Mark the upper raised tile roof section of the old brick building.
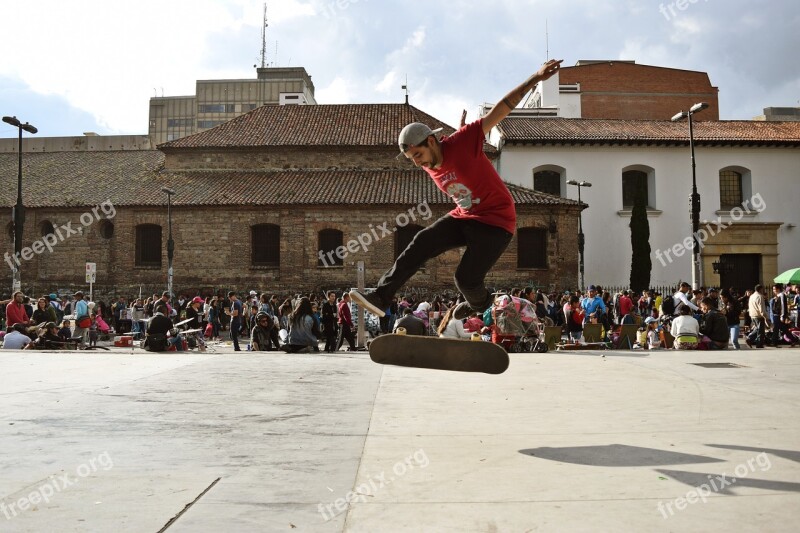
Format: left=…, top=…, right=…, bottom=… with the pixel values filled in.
left=159, top=104, right=455, bottom=151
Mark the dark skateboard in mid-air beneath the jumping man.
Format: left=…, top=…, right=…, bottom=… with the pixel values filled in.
left=369, top=334, right=508, bottom=374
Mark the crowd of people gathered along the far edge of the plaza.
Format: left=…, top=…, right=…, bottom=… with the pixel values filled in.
left=0, top=283, right=800, bottom=353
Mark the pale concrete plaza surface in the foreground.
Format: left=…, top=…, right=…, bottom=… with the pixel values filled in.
left=0, top=342, right=800, bottom=533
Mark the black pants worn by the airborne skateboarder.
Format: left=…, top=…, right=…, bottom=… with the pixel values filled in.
left=375, top=215, right=513, bottom=310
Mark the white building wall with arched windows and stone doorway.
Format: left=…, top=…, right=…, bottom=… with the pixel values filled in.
left=498, top=145, right=800, bottom=286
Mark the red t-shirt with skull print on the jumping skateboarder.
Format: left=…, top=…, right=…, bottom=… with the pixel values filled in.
left=425, top=120, right=517, bottom=234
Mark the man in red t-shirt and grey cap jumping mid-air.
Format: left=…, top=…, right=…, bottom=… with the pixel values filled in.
left=350, top=60, right=561, bottom=320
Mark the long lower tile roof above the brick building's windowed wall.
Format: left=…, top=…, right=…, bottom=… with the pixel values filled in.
left=0, top=150, right=578, bottom=208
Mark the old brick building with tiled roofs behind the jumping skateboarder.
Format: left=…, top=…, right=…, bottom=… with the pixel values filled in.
left=0, top=104, right=580, bottom=298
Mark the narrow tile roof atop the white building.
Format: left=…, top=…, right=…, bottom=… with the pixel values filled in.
left=498, top=117, right=800, bottom=146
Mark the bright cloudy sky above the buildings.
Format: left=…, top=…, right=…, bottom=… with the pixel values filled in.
left=0, top=0, right=800, bottom=137
